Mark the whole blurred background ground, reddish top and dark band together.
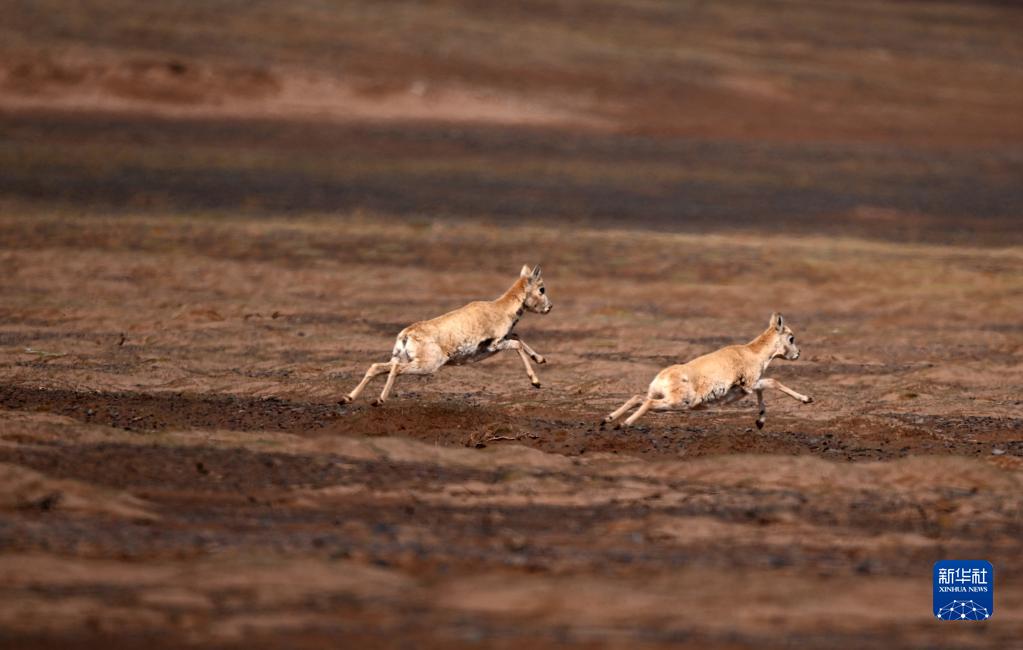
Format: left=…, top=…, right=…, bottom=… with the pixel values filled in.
left=6, top=0, right=1023, bottom=244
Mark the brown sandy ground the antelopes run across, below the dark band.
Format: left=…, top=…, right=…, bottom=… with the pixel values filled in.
left=0, top=215, right=1023, bottom=648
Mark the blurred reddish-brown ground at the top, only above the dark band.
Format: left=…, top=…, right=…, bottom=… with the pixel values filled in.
left=0, top=0, right=1023, bottom=146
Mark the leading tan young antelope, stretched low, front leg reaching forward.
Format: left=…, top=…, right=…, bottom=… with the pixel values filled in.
left=601, top=313, right=813, bottom=429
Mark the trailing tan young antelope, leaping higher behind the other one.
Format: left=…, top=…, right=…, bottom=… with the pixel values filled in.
left=340, top=266, right=551, bottom=406
